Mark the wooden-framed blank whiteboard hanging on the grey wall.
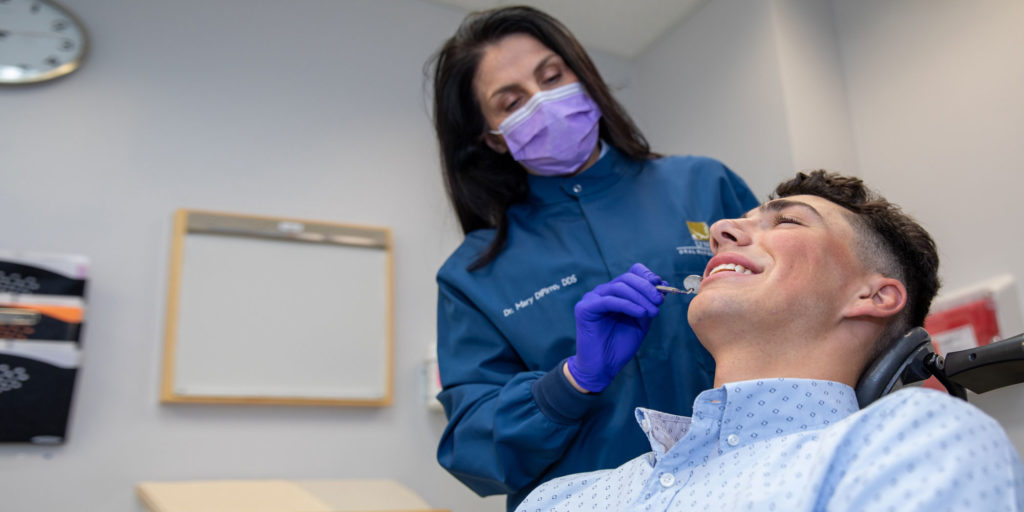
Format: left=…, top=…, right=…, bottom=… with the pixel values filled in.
left=161, top=210, right=394, bottom=406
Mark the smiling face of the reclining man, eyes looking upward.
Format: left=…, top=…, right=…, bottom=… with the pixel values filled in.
left=688, top=196, right=866, bottom=336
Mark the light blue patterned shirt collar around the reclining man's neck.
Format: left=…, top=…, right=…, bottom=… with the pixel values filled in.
left=636, top=379, right=858, bottom=459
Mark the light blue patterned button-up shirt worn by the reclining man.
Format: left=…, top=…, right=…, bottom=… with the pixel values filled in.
left=516, top=379, right=1024, bottom=512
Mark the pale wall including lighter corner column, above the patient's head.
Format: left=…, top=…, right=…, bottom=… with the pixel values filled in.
left=627, top=0, right=856, bottom=198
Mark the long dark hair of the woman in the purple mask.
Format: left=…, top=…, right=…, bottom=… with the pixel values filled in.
left=426, top=6, right=657, bottom=270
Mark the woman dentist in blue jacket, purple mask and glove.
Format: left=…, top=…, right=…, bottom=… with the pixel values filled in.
left=429, top=7, right=758, bottom=510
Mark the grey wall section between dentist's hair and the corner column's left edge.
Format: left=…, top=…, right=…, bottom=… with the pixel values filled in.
left=628, top=1, right=793, bottom=197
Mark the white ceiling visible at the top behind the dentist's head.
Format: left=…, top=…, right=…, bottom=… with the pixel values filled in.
left=428, top=0, right=708, bottom=58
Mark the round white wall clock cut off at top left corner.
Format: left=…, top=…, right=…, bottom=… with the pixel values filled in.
left=0, top=0, right=86, bottom=84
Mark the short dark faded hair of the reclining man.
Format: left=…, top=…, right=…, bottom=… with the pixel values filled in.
left=771, top=170, right=940, bottom=350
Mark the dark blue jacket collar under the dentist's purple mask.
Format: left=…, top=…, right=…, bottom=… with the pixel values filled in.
left=526, top=141, right=636, bottom=204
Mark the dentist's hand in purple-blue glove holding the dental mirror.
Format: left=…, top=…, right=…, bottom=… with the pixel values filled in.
left=567, top=263, right=665, bottom=393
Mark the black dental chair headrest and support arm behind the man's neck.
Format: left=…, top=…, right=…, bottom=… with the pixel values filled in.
left=856, top=327, right=1024, bottom=409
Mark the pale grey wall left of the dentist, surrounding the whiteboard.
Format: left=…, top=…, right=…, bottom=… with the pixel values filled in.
left=0, top=0, right=504, bottom=512
